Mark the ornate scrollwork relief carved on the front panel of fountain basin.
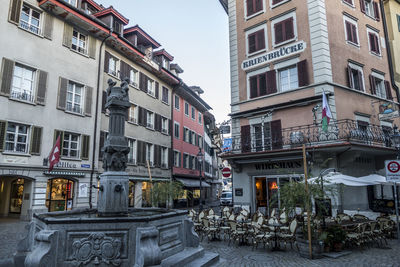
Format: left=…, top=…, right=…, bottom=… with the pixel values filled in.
left=72, top=233, right=121, bottom=266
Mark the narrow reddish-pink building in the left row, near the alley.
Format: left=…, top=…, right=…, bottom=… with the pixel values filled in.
left=172, top=83, right=211, bottom=206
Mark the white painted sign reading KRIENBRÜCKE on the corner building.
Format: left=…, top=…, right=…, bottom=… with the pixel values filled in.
left=242, top=41, right=307, bottom=70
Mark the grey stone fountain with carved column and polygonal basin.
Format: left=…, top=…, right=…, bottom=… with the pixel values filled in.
left=9, top=80, right=219, bottom=267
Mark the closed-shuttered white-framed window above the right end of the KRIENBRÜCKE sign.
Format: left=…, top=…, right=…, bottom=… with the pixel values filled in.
left=272, top=13, right=297, bottom=45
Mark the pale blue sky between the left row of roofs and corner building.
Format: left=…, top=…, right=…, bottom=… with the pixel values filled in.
left=96, top=0, right=230, bottom=123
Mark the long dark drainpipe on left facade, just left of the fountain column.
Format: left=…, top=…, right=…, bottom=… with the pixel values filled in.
left=89, top=28, right=113, bottom=209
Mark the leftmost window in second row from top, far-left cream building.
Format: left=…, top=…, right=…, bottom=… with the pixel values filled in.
left=11, top=64, right=35, bottom=102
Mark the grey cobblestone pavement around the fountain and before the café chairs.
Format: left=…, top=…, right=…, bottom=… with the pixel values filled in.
left=0, top=218, right=400, bottom=267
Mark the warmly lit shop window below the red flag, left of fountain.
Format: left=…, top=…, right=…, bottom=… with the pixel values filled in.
left=46, top=178, right=74, bottom=212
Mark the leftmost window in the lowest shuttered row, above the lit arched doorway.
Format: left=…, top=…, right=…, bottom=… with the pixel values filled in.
left=5, top=122, right=29, bottom=153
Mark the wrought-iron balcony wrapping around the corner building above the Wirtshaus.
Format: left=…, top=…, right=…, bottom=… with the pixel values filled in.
left=228, top=119, right=393, bottom=153
